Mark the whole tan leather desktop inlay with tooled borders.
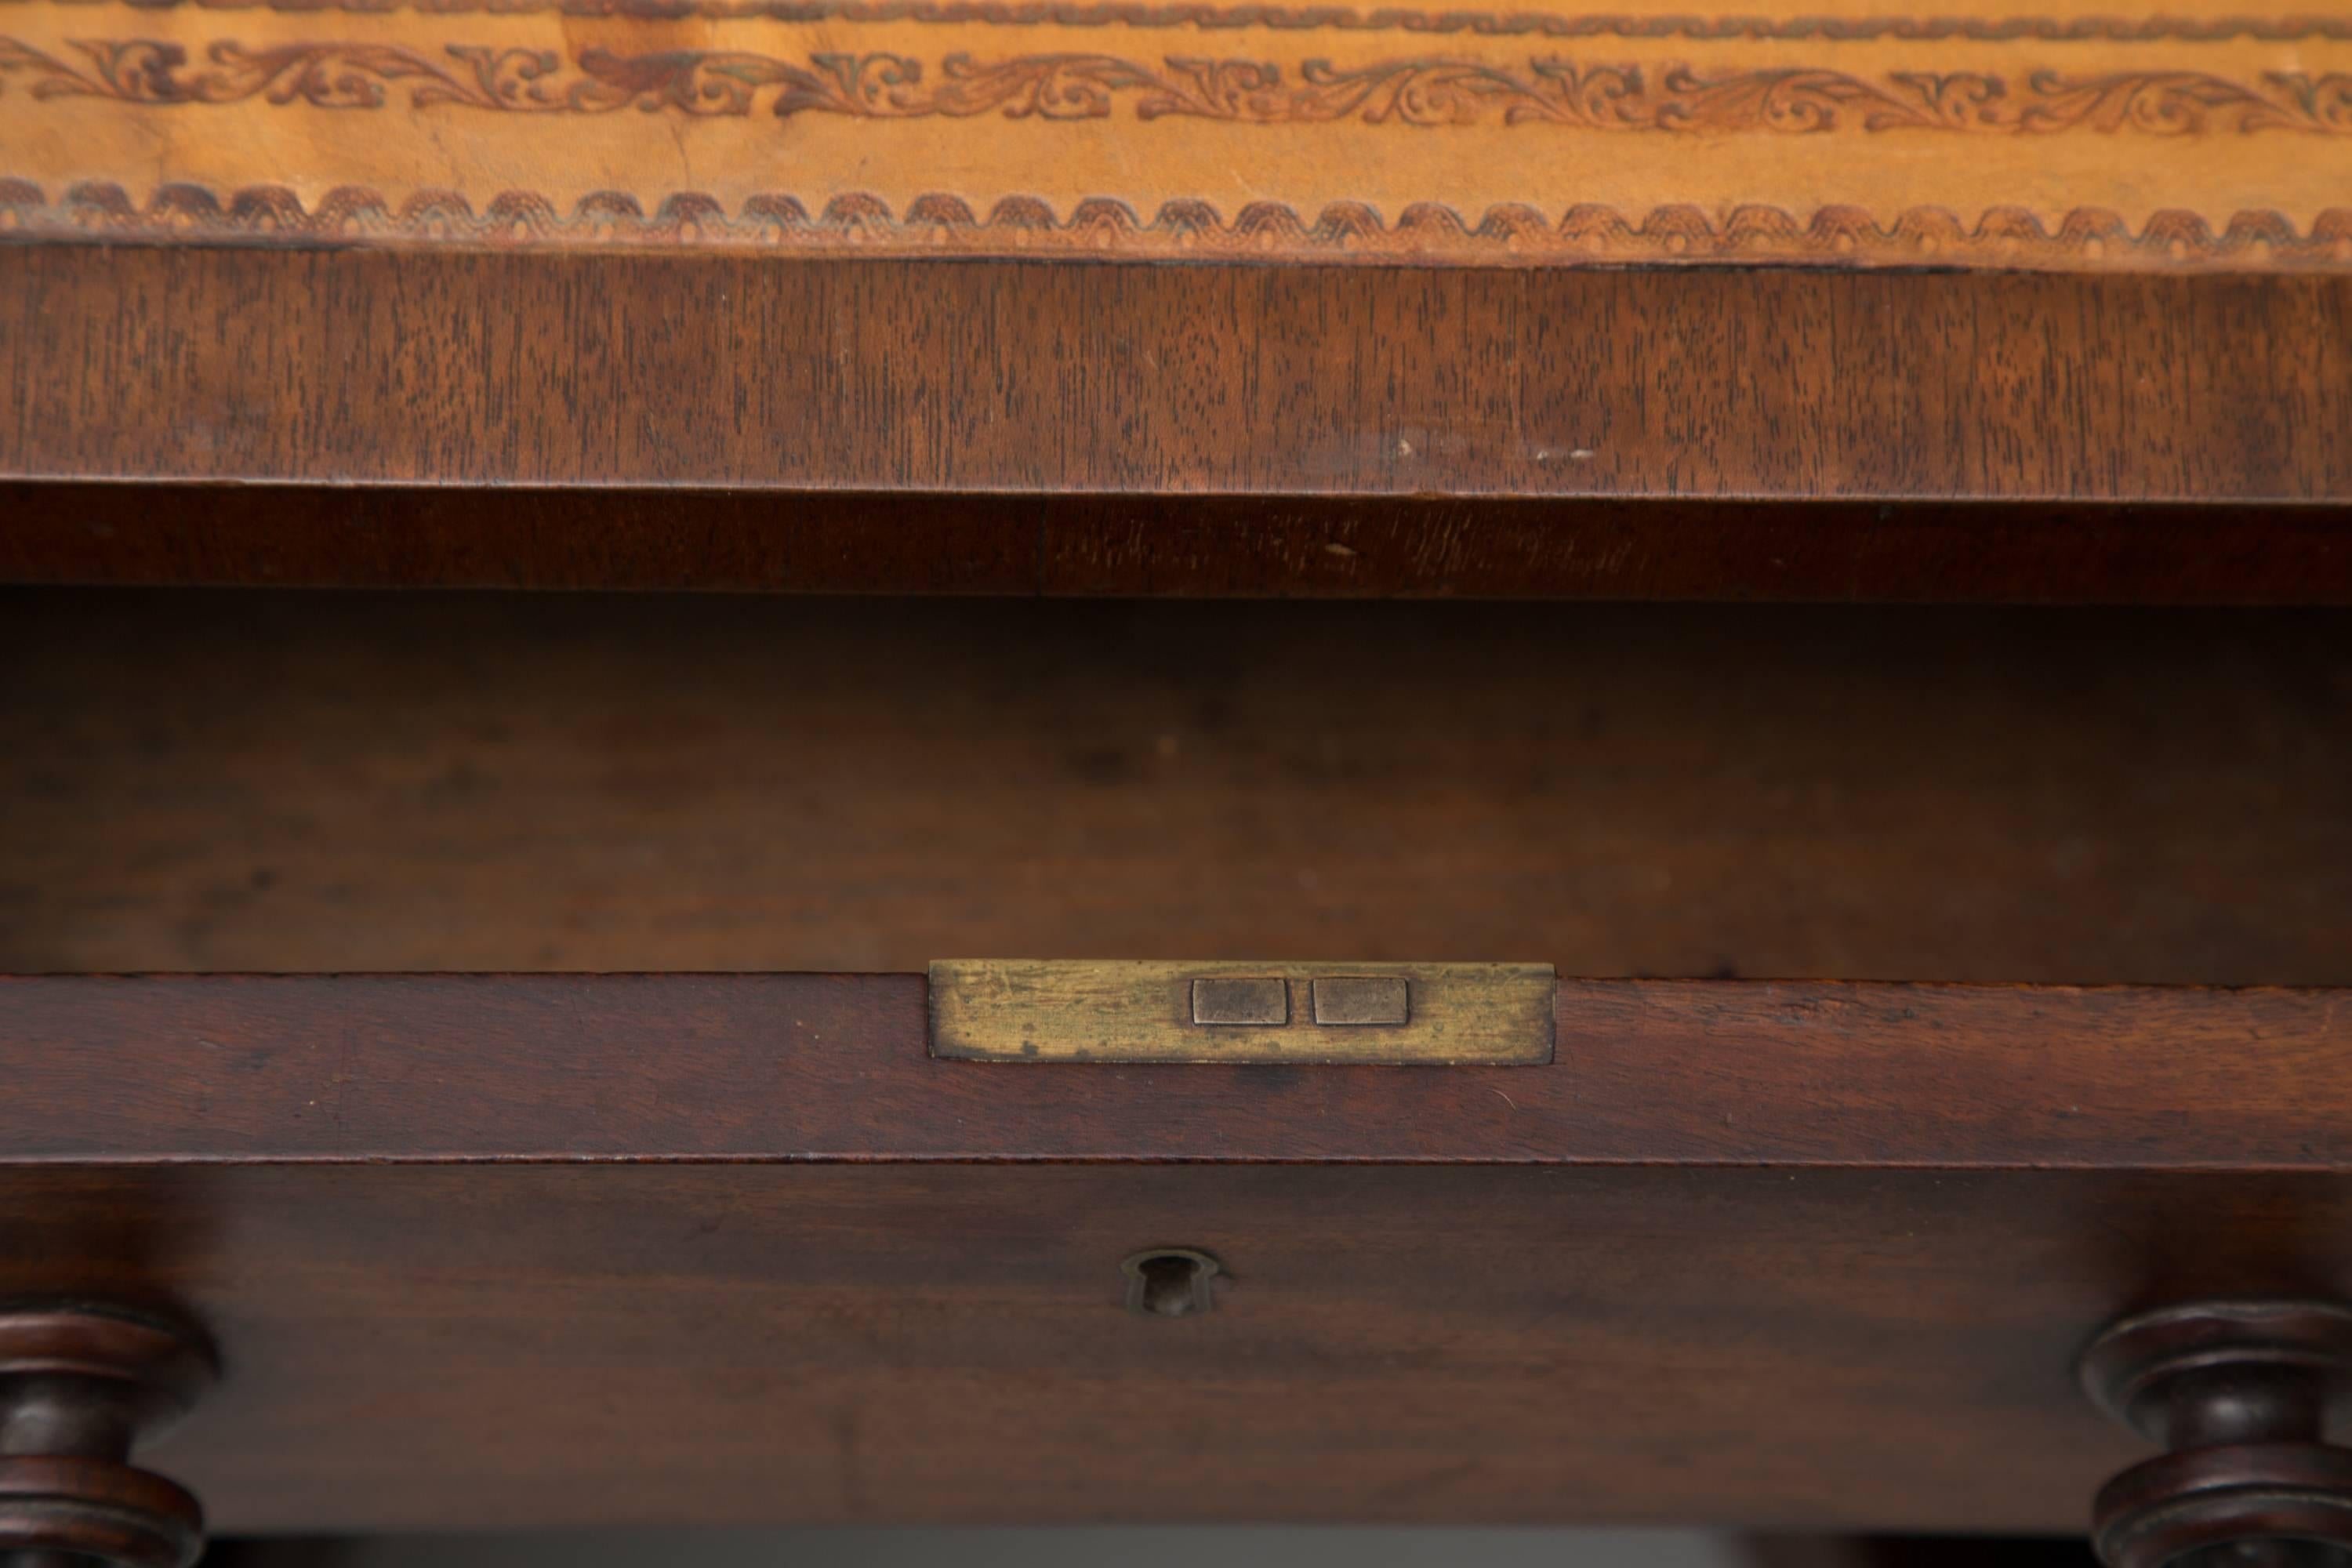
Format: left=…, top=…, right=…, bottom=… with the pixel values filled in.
left=0, top=0, right=2352, bottom=268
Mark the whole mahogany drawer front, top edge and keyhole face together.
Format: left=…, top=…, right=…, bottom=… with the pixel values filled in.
left=0, top=975, right=2352, bottom=1530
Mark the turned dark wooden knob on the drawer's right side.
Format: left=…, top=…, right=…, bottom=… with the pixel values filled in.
left=2082, top=1302, right=2352, bottom=1568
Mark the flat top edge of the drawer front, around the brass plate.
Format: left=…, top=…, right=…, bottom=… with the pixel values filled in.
left=0, top=975, right=2352, bottom=1173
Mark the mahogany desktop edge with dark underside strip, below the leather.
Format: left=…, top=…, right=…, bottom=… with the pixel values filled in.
left=0, top=255, right=2352, bottom=604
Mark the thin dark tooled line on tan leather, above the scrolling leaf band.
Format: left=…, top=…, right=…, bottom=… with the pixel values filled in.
left=0, top=0, right=2352, bottom=42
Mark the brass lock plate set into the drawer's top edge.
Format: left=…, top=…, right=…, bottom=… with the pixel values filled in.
left=931, top=959, right=1552, bottom=1067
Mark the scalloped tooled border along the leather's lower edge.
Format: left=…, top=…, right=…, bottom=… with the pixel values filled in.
left=0, top=179, right=2352, bottom=273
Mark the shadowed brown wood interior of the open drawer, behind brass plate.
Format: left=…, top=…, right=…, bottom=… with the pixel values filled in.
left=0, top=590, right=2352, bottom=985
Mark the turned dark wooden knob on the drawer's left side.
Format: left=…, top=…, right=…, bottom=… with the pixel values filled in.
left=0, top=1302, right=214, bottom=1568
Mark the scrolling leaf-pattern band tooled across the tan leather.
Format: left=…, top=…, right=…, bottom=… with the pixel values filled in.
left=0, top=38, right=2352, bottom=136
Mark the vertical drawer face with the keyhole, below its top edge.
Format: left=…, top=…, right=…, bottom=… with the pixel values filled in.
left=0, top=1166, right=2352, bottom=1533
